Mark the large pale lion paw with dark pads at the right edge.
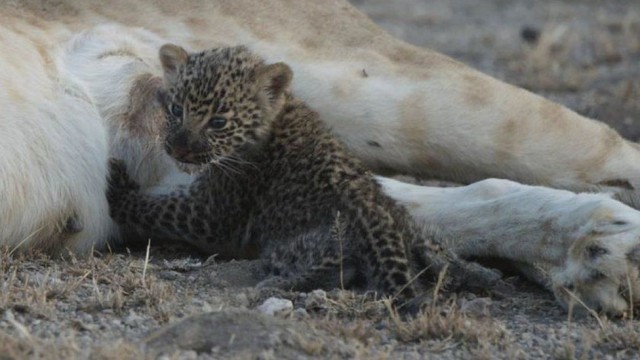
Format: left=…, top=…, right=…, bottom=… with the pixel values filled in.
left=550, top=200, right=640, bottom=315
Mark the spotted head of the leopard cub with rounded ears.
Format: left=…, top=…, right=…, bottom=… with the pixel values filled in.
left=160, top=44, right=293, bottom=164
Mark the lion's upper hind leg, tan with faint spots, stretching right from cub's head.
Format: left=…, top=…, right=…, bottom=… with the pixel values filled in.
left=293, top=58, right=640, bottom=202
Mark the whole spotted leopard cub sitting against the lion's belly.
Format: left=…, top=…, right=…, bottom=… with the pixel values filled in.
left=108, top=44, right=496, bottom=308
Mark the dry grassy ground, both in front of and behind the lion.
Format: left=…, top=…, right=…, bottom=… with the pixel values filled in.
left=0, top=0, right=640, bottom=359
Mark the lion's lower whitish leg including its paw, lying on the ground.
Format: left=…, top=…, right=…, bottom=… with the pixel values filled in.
left=378, top=177, right=640, bottom=314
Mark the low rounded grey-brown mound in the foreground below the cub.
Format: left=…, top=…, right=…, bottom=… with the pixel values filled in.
left=142, top=308, right=355, bottom=359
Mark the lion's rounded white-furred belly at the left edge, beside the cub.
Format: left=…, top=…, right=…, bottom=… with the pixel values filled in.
left=0, top=24, right=113, bottom=252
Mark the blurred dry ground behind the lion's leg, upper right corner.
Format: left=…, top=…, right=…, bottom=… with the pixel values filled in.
left=350, top=0, right=640, bottom=141
